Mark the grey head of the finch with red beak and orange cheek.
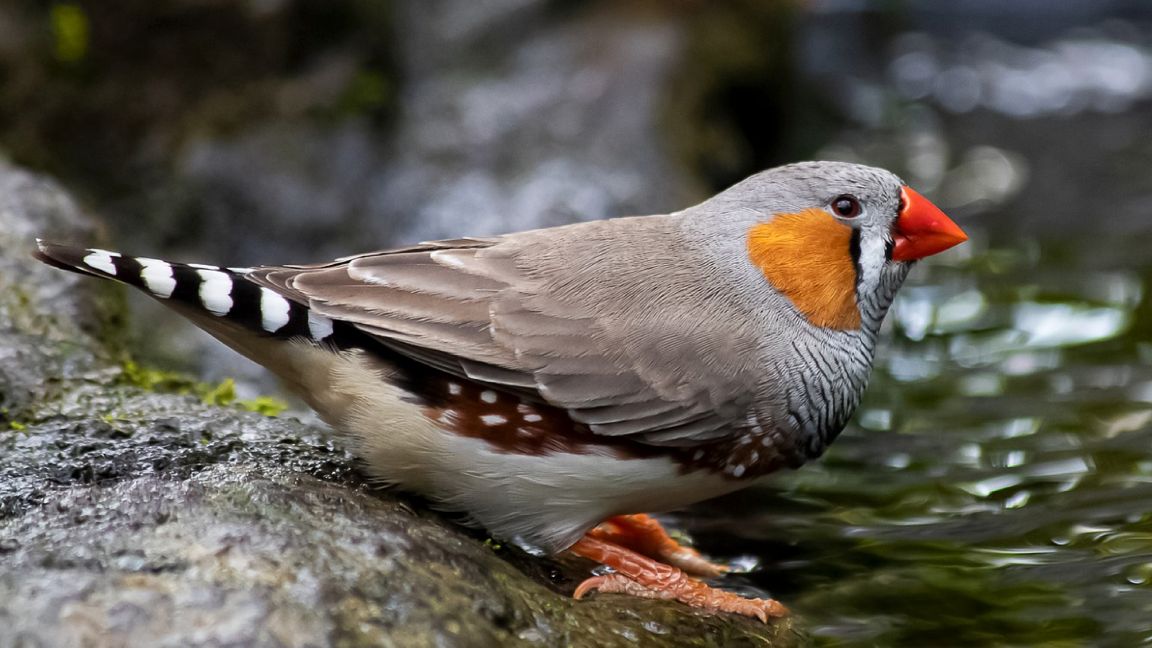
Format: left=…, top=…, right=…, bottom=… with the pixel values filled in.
left=697, top=161, right=968, bottom=331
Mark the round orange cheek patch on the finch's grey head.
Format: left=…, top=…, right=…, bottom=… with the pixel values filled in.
left=748, top=209, right=861, bottom=330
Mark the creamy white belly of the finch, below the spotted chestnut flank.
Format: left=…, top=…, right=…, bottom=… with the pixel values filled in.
left=281, top=344, right=746, bottom=551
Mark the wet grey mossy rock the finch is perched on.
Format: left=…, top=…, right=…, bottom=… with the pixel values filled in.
left=0, top=166, right=797, bottom=647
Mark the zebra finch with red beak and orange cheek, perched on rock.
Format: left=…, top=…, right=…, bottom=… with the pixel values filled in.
left=33, top=161, right=968, bottom=621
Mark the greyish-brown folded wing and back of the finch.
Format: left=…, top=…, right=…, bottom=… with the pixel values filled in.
left=249, top=217, right=757, bottom=445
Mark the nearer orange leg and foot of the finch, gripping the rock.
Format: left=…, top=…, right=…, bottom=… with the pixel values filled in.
left=569, top=534, right=788, bottom=623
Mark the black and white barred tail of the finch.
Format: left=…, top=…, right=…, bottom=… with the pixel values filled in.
left=33, top=240, right=334, bottom=342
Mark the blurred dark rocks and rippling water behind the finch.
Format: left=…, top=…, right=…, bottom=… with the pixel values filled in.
left=0, top=0, right=1152, bottom=647
